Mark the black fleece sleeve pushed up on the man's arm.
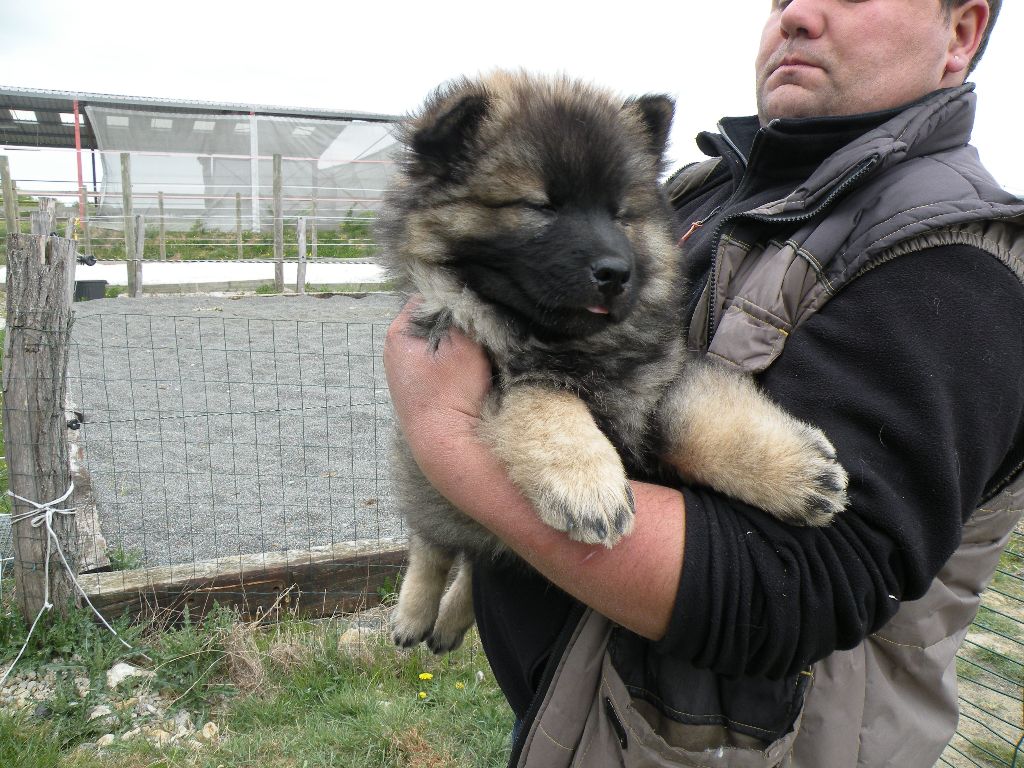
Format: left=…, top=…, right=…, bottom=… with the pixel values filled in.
left=658, top=247, right=1024, bottom=677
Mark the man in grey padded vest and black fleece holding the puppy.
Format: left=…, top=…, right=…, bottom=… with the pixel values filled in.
left=385, top=0, right=1024, bottom=768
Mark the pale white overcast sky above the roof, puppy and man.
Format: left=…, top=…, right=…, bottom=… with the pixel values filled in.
left=0, top=0, right=1024, bottom=195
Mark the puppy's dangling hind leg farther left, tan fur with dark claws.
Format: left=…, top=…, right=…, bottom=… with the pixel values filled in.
left=391, top=535, right=455, bottom=648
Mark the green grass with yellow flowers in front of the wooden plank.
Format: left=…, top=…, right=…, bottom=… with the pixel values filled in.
left=0, top=585, right=512, bottom=768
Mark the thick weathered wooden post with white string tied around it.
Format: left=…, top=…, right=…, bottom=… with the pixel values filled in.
left=3, top=234, right=77, bottom=622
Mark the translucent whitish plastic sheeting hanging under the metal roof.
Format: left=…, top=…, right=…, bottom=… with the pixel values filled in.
left=87, top=106, right=400, bottom=231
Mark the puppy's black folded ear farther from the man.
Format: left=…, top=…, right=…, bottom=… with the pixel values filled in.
left=409, top=92, right=488, bottom=178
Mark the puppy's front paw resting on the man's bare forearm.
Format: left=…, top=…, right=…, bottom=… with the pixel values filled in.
left=534, top=467, right=635, bottom=547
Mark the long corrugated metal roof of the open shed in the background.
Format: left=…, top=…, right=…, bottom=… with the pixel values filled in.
left=0, top=86, right=400, bottom=150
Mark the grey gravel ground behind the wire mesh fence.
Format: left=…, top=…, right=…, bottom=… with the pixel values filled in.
left=62, top=294, right=403, bottom=565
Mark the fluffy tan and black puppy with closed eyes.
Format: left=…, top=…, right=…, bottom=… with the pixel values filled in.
left=378, top=72, right=847, bottom=652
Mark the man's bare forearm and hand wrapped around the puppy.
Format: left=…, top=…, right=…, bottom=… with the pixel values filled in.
left=384, top=303, right=685, bottom=639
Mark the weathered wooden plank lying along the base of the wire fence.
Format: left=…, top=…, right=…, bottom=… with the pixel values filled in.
left=79, top=539, right=408, bottom=620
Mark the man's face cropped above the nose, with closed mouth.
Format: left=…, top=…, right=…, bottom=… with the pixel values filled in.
left=757, top=0, right=966, bottom=125
